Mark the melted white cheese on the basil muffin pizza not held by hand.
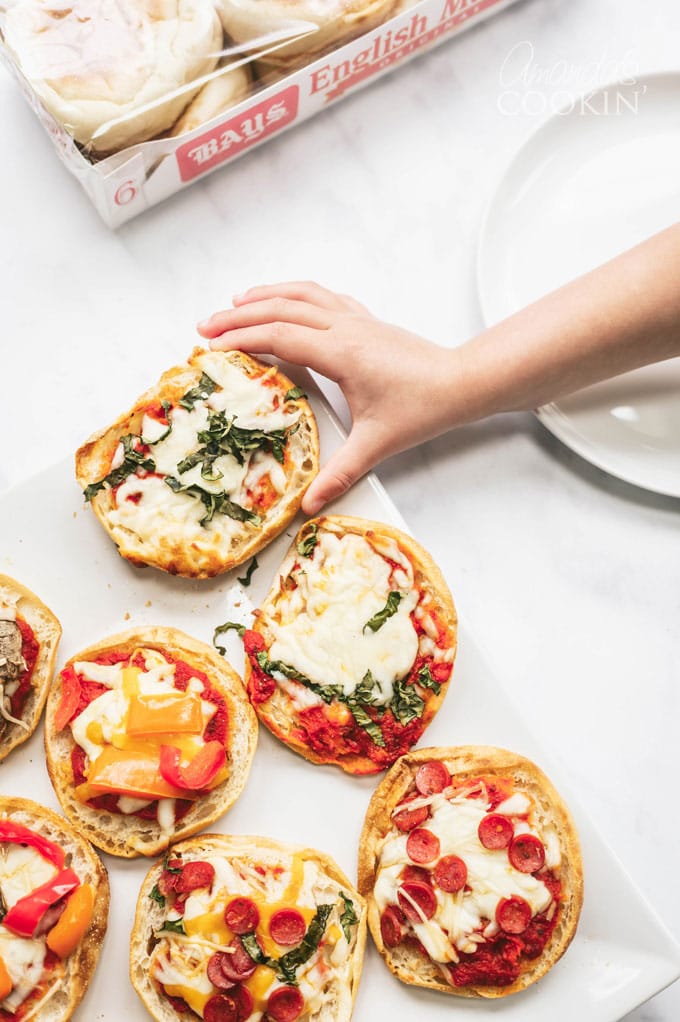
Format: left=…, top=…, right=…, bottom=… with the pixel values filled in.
left=269, top=531, right=418, bottom=705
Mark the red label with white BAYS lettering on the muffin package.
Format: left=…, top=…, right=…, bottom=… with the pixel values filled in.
left=175, top=85, right=300, bottom=182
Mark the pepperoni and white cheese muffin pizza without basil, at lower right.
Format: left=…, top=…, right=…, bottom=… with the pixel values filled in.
left=358, top=745, right=583, bottom=997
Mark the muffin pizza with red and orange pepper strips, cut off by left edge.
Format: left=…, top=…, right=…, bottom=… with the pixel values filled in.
left=0, top=796, right=109, bottom=1022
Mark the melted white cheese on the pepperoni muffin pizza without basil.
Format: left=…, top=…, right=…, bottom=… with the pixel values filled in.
left=375, top=794, right=557, bottom=962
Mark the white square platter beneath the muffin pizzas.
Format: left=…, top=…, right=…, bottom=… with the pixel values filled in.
left=0, top=371, right=680, bottom=1022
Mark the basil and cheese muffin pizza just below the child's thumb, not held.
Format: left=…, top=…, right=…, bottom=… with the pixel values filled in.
left=244, top=515, right=457, bottom=774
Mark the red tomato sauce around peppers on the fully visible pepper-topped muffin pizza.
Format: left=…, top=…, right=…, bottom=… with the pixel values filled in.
left=66, top=650, right=229, bottom=821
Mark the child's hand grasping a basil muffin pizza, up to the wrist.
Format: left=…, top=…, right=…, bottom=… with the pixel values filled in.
left=198, top=283, right=457, bottom=514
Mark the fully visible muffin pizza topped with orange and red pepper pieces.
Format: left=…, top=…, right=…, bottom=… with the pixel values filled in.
left=45, top=626, right=258, bottom=858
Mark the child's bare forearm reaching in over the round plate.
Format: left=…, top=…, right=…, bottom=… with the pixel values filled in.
left=450, top=225, right=680, bottom=426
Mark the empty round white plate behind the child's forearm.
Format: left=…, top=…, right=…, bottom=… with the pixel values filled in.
left=478, top=73, right=680, bottom=497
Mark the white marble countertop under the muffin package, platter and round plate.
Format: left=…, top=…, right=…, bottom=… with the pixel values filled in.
left=0, top=0, right=680, bottom=1022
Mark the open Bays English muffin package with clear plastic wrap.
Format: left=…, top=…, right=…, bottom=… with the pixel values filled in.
left=0, top=0, right=514, bottom=227
